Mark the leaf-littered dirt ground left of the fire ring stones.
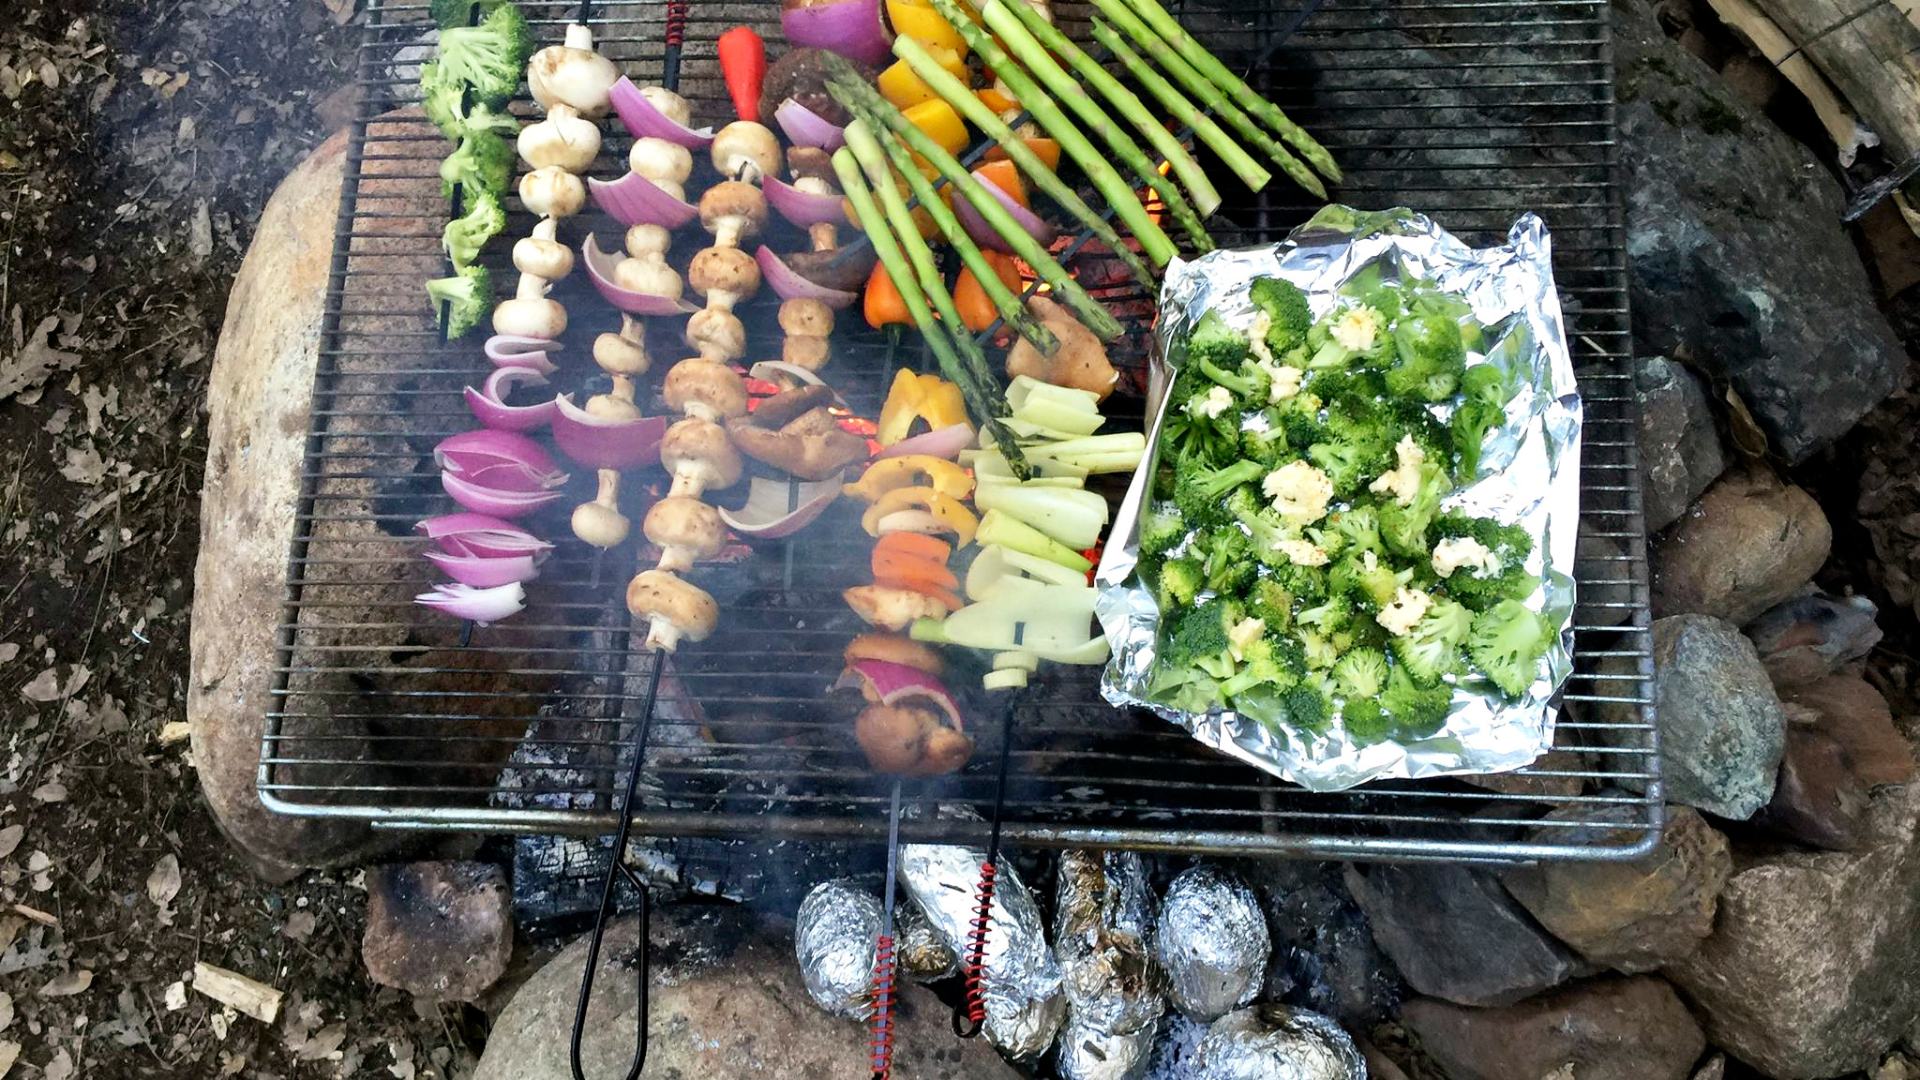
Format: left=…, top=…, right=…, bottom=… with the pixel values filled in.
left=0, top=0, right=472, bottom=1080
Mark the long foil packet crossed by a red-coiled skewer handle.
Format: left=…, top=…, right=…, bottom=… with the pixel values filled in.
left=899, top=844, right=1068, bottom=1061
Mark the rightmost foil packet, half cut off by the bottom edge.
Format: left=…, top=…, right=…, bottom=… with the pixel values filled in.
left=1190, top=1005, right=1367, bottom=1080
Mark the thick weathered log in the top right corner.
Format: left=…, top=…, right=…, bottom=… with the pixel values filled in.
left=1751, top=0, right=1920, bottom=161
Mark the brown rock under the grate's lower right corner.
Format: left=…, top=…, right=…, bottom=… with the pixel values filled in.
left=1505, top=805, right=1734, bottom=974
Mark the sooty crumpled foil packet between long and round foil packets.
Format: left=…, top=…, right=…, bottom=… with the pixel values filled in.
left=1054, top=851, right=1167, bottom=1043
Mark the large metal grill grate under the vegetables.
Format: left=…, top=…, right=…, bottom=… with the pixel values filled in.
left=259, top=0, right=1661, bottom=859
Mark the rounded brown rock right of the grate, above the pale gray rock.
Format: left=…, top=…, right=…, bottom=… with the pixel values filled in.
left=1651, top=473, right=1834, bottom=626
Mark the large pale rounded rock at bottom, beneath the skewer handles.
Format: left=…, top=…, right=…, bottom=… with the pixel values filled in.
left=472, top=907, right=1020, bottom=1080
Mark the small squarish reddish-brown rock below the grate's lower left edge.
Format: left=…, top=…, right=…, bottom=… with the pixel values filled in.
left=361, top=863, right=513, bottom=1001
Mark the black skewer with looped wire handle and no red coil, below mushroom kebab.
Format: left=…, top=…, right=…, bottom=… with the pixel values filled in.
left=566, top=0, right=687, bottom=1080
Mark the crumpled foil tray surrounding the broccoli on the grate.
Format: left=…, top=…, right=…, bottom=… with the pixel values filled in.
left=1094, top=206, right=1580, bottom=792
